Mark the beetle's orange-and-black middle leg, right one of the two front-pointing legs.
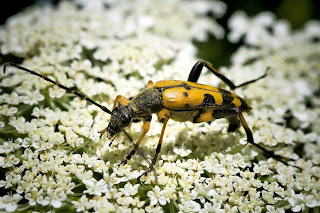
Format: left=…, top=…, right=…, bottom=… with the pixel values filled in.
left=138, top=109, right=170, bottom=179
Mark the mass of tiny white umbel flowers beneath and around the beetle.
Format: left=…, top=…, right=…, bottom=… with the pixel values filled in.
left=0, top=0, right=320, bottom=212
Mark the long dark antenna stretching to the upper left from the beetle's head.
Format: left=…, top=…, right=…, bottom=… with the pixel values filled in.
left=3, top=62, right=112, bottom=114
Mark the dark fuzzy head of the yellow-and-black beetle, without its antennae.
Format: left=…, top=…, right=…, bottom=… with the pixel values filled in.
left=107, top=103, right=133, bottom=139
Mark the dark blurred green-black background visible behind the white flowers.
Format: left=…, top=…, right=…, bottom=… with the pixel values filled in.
left=0, top=0, right=320, bottom=67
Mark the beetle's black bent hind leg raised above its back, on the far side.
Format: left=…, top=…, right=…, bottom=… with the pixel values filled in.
left=188, top=61, right=270, bottom=90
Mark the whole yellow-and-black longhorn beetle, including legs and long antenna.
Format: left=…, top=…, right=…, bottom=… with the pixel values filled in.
left=3, top=61, right=300, bottom=179
